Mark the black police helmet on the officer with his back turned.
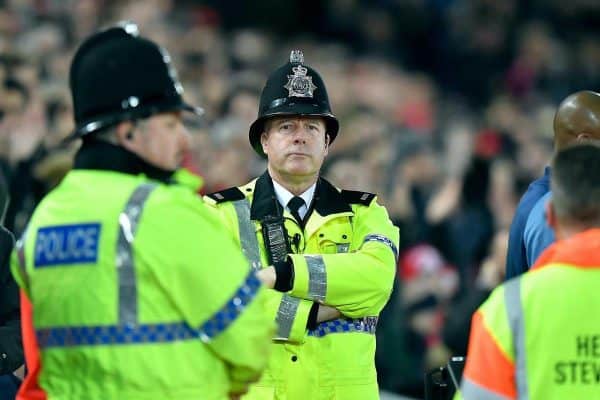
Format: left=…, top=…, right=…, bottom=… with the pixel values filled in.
left=70, top=22, right=202, bottom=138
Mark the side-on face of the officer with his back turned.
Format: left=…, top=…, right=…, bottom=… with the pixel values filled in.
left=132, top=112, right=190, bottom=171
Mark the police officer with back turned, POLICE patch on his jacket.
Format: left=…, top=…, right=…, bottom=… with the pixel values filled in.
left=12, top=23, right=273, bottom=400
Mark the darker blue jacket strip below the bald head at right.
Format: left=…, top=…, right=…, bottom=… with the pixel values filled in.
left=506, top=167, right=550, bottom=280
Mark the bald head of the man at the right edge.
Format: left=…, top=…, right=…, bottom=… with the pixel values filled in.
left=554, top=90, right=600, bottom=151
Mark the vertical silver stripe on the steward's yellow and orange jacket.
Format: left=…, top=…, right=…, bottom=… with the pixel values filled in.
left=504, top=278, right=529, bottom=400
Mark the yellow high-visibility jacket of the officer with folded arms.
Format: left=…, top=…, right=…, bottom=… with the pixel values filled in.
left=207, top=173, right=399, bottom=400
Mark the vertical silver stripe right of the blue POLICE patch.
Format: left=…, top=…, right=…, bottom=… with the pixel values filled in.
left=116, top=183, right=157, bottom=325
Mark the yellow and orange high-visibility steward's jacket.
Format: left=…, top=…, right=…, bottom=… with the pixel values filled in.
left=461, top=229, right=600, bottom=400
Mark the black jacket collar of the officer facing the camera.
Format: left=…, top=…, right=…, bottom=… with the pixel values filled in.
left=250, top=172, right=352, bottom=221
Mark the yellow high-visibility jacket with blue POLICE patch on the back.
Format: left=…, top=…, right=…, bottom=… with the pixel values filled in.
left=11, top=170, right=273, bottom=400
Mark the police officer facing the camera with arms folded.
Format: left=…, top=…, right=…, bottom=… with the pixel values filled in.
left=207, top=51, right=399, bottom=400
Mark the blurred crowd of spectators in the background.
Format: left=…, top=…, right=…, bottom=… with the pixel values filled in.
left=0, top=0, right=600, bottom=397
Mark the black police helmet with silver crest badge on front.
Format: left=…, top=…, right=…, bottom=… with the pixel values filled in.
left=250, top=50, right=340, bottom=157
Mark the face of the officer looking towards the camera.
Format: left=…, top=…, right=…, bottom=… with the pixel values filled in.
left=260, top=116, right=329, bottom=181
